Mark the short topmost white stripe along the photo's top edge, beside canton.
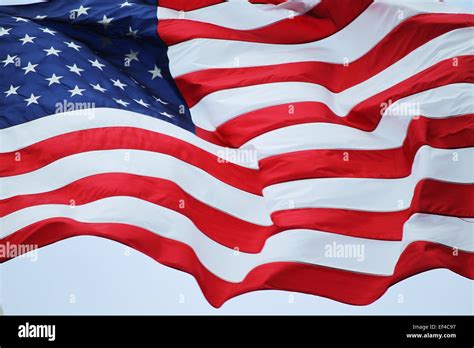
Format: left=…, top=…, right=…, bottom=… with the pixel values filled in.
left=158, top=0, right=319, bottom=30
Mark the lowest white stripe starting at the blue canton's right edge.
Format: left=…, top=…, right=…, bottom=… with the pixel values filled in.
left=191, top=28, right=474, bottom=131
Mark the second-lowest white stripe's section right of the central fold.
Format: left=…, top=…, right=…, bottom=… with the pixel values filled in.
left=263, top=146, right=474, bottom=212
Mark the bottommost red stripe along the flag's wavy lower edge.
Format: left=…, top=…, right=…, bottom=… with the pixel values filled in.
left=0, top=218, right=474, bottom=307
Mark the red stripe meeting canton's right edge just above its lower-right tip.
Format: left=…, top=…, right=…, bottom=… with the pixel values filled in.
left=176, top=14, right=474, bottom=107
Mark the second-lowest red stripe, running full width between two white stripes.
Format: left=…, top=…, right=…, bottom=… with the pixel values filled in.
left=0, top=177, right=468, bottom=247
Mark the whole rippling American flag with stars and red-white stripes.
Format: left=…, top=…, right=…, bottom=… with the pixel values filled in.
left=0, top=0, right=474, bottom=307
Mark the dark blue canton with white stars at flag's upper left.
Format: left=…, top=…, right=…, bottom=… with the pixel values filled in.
left=0, top=0, right=194, bottom=131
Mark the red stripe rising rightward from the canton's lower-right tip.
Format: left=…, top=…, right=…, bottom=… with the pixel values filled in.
left=196, top=56, right=474, bottom=147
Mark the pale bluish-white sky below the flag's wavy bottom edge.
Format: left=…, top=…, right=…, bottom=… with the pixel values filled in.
left=0, top=0, right=474, bottom=315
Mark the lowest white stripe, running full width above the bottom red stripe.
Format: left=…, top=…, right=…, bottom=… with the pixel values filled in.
left=0, top=197, right=474, bottom=282
